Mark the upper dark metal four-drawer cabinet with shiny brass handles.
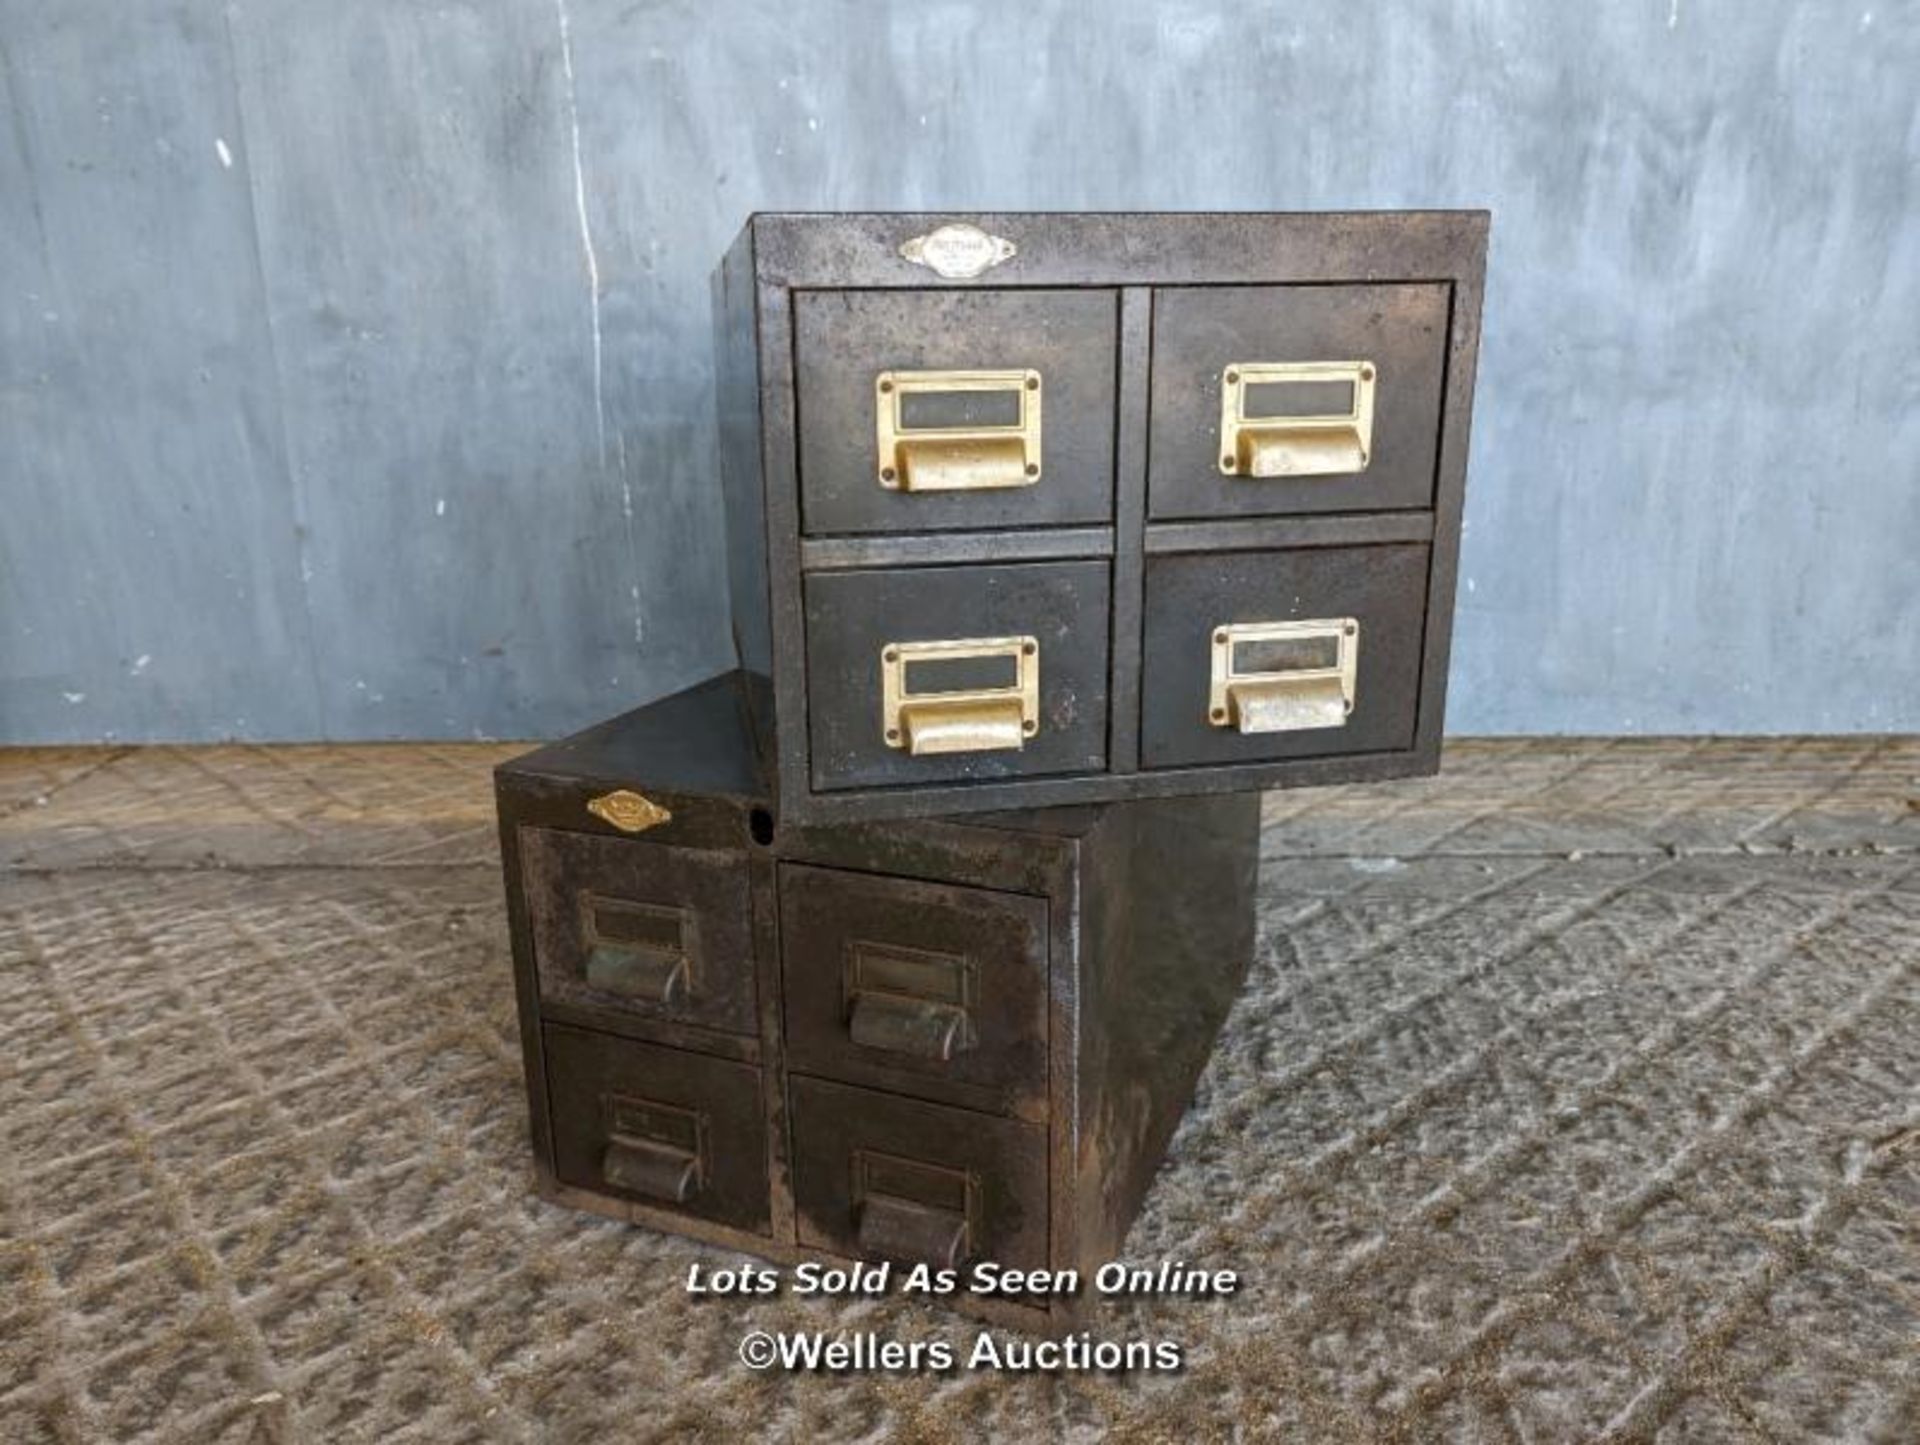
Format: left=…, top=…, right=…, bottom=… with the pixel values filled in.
left=714, top=211, right=1488, bottom=821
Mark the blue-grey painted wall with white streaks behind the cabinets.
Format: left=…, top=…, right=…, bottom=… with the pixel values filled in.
left=0, top=0, right=1920, bottom=743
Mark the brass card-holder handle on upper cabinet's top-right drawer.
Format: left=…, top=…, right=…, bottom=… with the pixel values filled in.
left=1219, top=361, right=1375, bottom=478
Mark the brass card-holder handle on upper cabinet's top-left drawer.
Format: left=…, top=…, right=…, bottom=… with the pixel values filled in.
left=874, top=370, right=1041, bottom=491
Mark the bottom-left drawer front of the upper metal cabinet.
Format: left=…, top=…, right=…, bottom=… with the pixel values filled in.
left=806, top=560, right=1110, bottom=791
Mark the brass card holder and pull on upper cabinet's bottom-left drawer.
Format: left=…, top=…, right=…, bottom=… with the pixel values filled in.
left=879, top=637, right=1041, bottom=758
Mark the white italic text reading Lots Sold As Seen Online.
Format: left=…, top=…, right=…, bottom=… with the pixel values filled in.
left=687, top=1261, right=1240, bottom=1299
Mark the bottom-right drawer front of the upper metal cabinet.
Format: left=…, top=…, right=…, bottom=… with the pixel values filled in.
left=1140, top=545, right=1428, bottom=768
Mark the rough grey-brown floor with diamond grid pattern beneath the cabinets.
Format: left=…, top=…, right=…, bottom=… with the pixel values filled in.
left=0, top=739, right=1920, bottom=1443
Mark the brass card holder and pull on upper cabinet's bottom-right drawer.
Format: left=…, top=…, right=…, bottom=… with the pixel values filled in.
left=1208, top=618, right=1359, bottom=735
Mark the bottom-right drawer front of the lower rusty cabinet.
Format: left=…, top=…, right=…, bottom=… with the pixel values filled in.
left=789, top=1075, right=1046, bottom=1268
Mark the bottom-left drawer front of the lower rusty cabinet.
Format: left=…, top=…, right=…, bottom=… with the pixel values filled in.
left=545, top=1025, right=772, bottom=1234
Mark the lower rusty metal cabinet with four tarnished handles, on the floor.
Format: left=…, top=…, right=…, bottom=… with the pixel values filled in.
left=495, top=674, right=1260, bottom=1326
